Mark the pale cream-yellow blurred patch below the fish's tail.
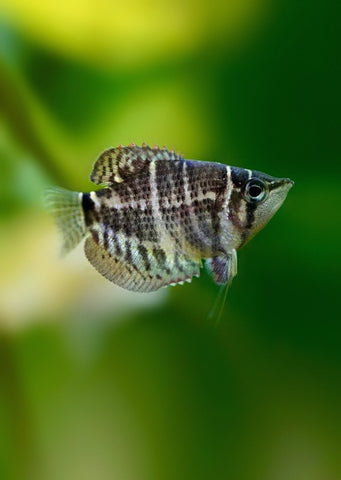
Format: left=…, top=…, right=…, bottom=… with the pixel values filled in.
left=0, top=212, right=167, bottom=331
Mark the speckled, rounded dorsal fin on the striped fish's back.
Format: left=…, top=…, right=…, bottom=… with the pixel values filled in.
left=90, top=143, right=182, bottom=185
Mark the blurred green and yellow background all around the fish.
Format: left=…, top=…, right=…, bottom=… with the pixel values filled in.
left=0, top=0, right=341, bottom=480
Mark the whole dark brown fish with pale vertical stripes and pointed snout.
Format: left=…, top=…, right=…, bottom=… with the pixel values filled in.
left=45, top=143, right=294, bottom=292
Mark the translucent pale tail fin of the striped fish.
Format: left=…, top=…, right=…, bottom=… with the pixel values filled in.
left=45, top=187, right=86, bottom=255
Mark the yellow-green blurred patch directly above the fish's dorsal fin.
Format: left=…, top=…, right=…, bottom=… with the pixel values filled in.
left=88, top=82, right=213, bottom=155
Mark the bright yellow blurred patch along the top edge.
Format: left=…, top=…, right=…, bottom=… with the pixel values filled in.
left=2, top=0, right=264, bottom=68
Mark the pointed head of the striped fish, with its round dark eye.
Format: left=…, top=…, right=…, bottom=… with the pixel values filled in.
left=231, top=167, right=294, bottom=244
